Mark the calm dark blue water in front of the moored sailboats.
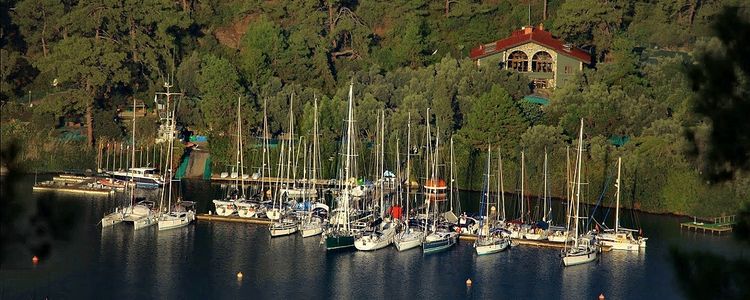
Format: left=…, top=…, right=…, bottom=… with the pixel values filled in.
left=0, top=176, right=747, bottom=299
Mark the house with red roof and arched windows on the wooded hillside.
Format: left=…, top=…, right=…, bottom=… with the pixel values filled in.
left=469, top=24, right=591, bottom=89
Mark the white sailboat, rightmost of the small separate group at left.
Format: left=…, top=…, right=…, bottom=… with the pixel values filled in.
left=157, top=91, right=195, bottom=231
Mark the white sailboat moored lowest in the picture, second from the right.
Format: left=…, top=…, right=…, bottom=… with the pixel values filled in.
left=561, top=119, right=598, bottom=267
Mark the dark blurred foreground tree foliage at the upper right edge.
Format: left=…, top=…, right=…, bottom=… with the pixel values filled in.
left=688, top=8, right=750, bottom=180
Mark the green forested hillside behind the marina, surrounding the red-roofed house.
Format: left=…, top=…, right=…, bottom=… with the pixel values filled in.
left=0, top=0, right=750, bottom=216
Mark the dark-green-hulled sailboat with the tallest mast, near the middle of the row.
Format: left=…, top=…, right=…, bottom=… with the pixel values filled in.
left=323, top=82, right=356, bottom=250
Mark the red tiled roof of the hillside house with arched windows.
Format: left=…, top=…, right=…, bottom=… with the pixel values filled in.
left=469, top=27, right=591, bottom=64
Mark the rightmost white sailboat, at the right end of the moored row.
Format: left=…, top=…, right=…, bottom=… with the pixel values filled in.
left=596, top=157, right=648, bottom=251
